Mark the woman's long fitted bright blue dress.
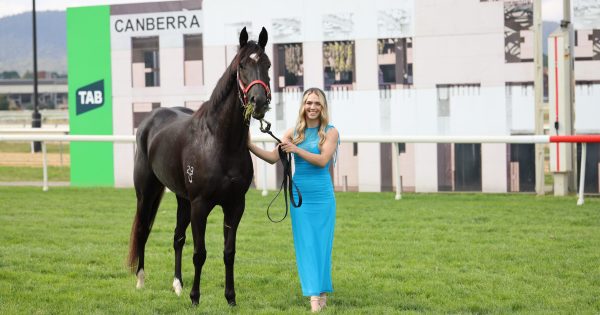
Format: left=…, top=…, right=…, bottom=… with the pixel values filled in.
left=291, top=125, right=335, bottom=296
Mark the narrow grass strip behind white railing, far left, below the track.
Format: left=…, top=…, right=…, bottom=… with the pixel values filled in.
left=0, top=166, right=71, bottom=183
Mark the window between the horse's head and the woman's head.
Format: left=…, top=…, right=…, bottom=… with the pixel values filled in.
left=273, top=43, right=304, bottom=92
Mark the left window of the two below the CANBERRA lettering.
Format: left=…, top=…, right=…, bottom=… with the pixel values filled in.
left=131, top=36, right=160, bottom=87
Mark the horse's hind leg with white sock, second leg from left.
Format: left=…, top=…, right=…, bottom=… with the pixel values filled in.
left=173, top=196, right=191, bottom=296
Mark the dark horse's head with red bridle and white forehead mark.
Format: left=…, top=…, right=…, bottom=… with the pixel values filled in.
left=237, top=27, right=271, bottom=119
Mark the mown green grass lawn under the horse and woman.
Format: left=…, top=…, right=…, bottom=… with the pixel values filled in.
left=0, top=188, right=600, bottom=314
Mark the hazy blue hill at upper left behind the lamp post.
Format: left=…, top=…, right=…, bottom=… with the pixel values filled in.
left=0, top=11, right=67, bottom=76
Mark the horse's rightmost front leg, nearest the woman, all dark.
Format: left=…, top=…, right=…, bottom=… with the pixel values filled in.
left=223, top=196, right=246, bottom=306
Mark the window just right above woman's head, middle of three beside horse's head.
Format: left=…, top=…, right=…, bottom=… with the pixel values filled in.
left=323, top=41, right=356, bottom=91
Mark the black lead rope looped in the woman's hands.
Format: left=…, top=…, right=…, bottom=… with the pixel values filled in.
left=260, top=119, right=302, bottom=223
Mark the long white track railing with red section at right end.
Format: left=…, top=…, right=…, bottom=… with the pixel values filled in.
left=0, top=129, right=600, bottom=205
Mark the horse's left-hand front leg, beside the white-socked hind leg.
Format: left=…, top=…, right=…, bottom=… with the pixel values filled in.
left=190, top=197, right=214, bottom=305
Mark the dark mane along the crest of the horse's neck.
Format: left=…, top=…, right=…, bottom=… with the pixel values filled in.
left=194, top=41, right=264, bottom=115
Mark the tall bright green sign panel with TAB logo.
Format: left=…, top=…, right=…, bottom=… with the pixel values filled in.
left=67, top=6, right=115, bottom=186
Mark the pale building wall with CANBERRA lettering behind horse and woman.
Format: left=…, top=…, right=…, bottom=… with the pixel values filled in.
left=67, top=0, right=600, bottom=192
